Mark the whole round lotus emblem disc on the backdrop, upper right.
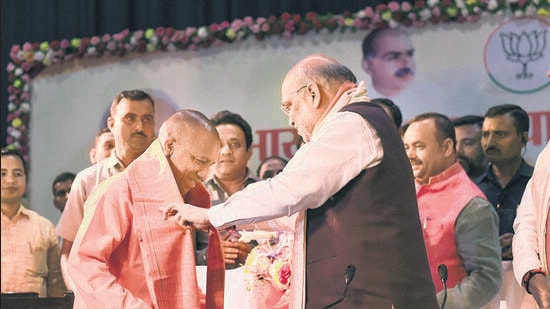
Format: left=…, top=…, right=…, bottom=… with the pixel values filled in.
left=484, top=17, right=550, bottom=93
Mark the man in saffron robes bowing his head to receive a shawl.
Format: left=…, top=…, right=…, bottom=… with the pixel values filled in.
left=69, top=110, right=224, bottom=308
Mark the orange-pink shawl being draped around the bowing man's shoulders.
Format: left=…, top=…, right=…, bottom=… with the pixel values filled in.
left=126, top=140, right=225, bottom=309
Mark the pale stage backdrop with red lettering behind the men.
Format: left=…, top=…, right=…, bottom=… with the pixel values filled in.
left=19, top=15, right=550, bottom=223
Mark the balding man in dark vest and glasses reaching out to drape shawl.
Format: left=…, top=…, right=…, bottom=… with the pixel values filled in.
left=167, top=54, right=439, bottom=308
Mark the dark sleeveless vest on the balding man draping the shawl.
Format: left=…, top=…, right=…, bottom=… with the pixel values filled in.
left=306, top=102, right=439, bottom=309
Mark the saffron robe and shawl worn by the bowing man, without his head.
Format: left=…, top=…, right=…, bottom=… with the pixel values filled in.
left=69, top=141, right=223, bottom=309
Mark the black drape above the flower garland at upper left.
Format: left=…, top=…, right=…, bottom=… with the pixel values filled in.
left=0, top=0, right=388, bottom=147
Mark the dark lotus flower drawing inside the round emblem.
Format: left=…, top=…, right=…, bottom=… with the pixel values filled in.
left=500, top=30, right=548, bottom=79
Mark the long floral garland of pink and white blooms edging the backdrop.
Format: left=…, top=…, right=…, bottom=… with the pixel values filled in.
left=6, top=0, right=550, bottom=161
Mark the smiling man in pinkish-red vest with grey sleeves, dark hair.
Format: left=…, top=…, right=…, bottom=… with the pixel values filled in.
left=403, top=113, right=502, bottom=308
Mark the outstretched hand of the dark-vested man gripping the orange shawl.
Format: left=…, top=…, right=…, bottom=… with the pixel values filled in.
left=160, top=204, right=210, bottom=230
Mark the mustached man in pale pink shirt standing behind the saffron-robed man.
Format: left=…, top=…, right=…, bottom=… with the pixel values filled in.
left=55, top=90, right=155, bottom=290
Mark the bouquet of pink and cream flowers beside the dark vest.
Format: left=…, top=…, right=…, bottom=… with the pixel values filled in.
left=244, top=233, right=294, bottom=308
